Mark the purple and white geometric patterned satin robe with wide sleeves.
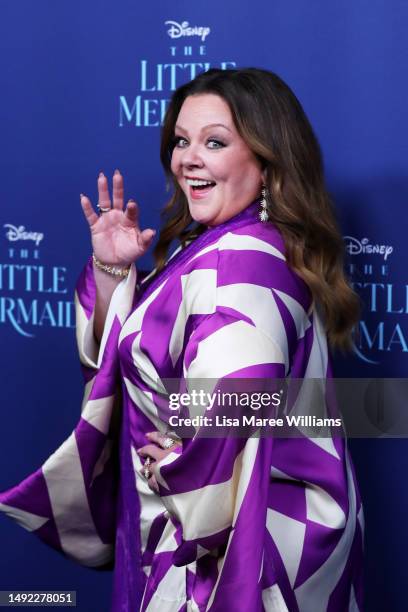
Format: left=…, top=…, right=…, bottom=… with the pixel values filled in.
left=0, top=202, right=363, bottom=612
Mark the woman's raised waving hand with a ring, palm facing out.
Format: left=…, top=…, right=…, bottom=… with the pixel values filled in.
left=81, top=170, right=156, bottom=266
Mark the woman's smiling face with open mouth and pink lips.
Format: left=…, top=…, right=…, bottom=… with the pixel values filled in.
left=171, top=94, right=263, bottom=226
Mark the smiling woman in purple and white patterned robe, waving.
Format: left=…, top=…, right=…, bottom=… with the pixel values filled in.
left=0, top=69, right=363, bottom=612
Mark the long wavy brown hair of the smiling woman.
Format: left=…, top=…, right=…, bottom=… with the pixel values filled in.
left=154, top=68, right=360, bottom=349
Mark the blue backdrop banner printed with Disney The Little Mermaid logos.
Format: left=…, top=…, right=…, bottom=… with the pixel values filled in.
left=0, top=0, right=408, bottom=612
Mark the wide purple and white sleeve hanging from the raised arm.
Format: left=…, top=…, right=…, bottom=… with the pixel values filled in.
left=0, top=262, right=136, bottom=567
